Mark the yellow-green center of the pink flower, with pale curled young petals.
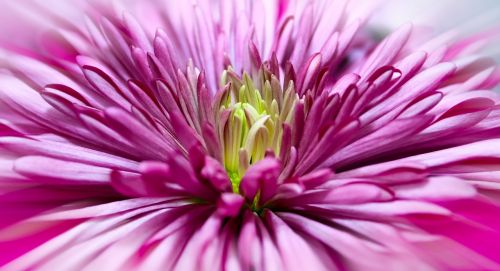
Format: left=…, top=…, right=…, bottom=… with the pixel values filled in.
left=216, top=69, right=298, bottom=193
